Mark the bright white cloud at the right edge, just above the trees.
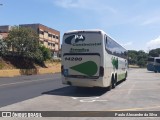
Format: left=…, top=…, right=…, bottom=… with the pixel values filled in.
left=146, top=36, right=160, bottom=49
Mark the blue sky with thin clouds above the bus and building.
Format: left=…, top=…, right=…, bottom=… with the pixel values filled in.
left=0, top=0, right=160, bottom=51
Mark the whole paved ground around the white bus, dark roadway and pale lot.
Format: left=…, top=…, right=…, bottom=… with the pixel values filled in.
left=0, top=69, right=160, bottom=120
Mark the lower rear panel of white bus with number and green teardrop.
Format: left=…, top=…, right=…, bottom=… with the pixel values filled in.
left=62, top=54, right=100, bottom=78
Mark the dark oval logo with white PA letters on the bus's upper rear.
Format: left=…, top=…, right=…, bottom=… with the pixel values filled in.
left=65, top=35, right=85, bottom=45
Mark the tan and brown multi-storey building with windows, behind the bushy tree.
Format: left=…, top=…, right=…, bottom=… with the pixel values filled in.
left=19, top=24, right=60, bottom=56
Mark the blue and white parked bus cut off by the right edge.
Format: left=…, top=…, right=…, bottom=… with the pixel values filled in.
left=147, top=57, right=160, bottom=73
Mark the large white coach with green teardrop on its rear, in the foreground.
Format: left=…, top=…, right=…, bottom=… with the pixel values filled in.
left=61, top=30, right=128, bottom=89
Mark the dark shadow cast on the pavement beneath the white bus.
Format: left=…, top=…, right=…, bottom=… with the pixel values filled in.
left=42, top=86, right=108, bottom=97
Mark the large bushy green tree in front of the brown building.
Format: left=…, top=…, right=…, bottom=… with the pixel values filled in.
left=5, top=26, right=43, bottom=60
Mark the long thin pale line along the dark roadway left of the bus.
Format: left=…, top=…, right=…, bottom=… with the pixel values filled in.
left=0, top=78, right=53, bottom=87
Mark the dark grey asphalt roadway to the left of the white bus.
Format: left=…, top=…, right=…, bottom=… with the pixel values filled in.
left=0, top=74, right=64, bottom=107
